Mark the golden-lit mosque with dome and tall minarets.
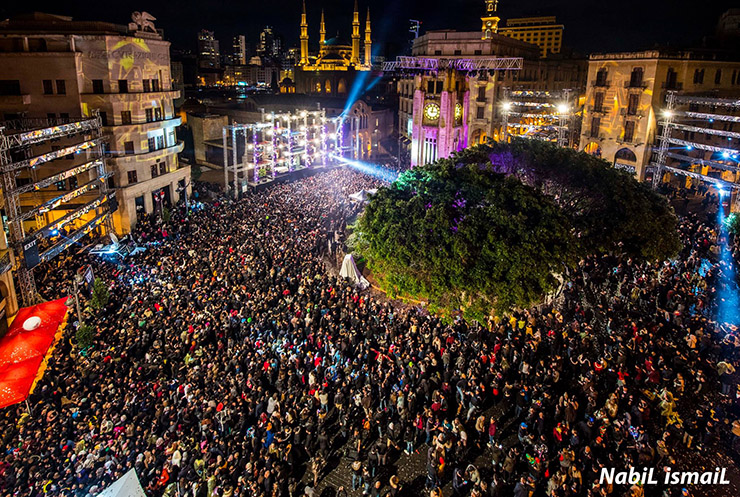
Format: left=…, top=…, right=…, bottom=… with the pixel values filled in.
left=295, top=1, right=372, bottom=96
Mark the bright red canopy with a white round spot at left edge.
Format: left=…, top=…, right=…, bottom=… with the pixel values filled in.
left=0, top=297, right=67, bottom=408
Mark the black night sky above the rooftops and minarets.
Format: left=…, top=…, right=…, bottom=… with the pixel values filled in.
left=0, top=0, right=740, bottom=56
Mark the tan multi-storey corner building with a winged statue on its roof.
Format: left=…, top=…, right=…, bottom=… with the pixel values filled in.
left=0, top=13, right=190, bottom=233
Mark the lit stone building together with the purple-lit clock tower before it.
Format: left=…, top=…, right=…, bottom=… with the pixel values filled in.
left=398, top=2, right=586, bottom=165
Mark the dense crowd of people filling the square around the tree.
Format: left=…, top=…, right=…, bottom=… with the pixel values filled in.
left=0, top=169, right=740, bottom=497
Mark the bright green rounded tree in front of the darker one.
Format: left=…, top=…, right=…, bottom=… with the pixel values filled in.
left=358, top=153, right=577, bottom=317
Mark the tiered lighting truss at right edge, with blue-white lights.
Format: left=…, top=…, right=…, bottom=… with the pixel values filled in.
left=648, top=92, right=740, bottom=200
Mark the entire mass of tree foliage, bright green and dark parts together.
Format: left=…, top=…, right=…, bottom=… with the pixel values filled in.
left=355, top=140, right=679, bottom=318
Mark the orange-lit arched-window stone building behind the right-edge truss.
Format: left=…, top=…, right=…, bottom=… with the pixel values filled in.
left=580, top=51, right=740, bottom=179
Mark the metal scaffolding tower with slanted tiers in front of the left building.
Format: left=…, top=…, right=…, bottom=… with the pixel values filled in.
left=0, top=112, right=112, bottom=306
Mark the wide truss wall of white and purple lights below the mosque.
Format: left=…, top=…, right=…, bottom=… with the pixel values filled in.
left=223, top=109, right=336, bottom=196
